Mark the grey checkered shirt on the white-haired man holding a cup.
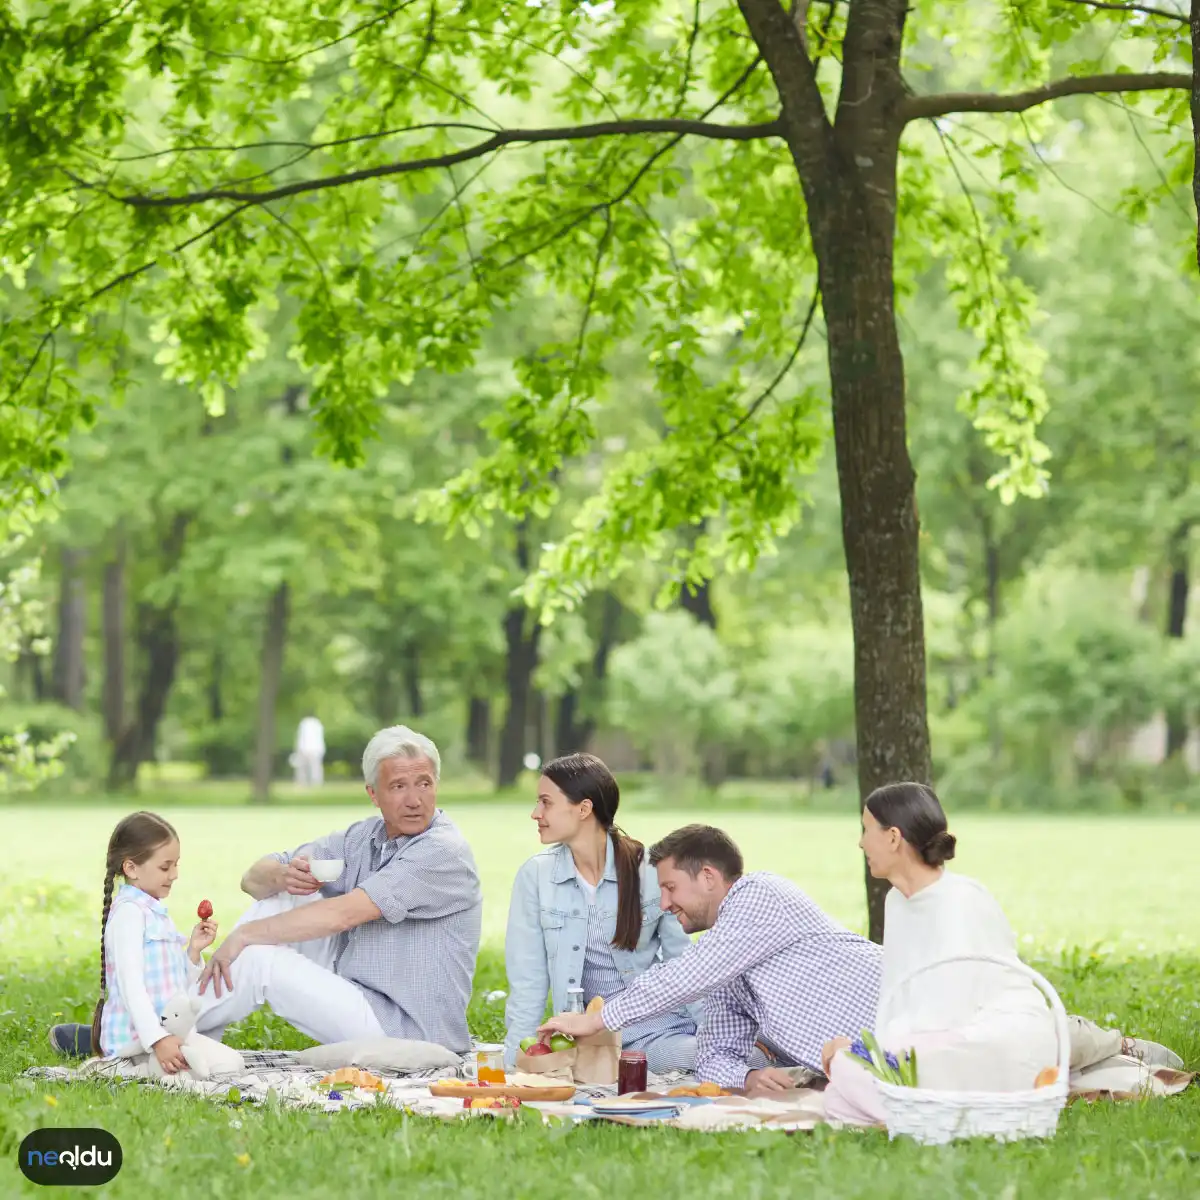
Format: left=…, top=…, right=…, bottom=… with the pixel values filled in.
left=271, top=809, right=484, bottom=1054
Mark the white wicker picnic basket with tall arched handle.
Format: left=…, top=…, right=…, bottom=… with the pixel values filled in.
left=878, top=954, right=1070, bottom=1146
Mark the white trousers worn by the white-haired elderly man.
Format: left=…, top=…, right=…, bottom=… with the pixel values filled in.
left=196, top=892, right=386, bottom=1044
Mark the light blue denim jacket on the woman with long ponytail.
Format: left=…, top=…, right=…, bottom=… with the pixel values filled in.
left=504, top=838, right=702, bottom=1066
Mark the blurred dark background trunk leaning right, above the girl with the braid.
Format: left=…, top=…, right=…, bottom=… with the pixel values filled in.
left=108, top=512, right=191, bottom=791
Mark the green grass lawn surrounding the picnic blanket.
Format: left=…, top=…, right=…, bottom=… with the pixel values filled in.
left=0, top=794, right=1200, bottom=1200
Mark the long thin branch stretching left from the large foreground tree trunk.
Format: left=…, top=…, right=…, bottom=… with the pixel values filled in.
left=77, top=118, right=784, bottom=209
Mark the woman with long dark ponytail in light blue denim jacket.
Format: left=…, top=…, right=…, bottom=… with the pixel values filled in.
left=504, top=754, right=698, bottom=1074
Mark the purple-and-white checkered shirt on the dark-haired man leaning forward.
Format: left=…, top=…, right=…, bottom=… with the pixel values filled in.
left=602, top=871, right=883, bottom=1087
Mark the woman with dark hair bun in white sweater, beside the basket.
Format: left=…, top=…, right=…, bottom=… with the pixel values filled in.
left=824, top=784, right=1057, bottom=1124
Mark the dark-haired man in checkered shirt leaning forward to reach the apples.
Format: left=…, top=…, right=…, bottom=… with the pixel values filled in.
left=542, top=826, right=882, bottom=1093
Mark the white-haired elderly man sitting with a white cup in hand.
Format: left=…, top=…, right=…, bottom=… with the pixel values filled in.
left=189, top=725, right=484, bottom=1054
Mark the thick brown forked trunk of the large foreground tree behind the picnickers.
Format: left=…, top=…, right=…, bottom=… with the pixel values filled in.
left=738, top=0, right=931, bottom=941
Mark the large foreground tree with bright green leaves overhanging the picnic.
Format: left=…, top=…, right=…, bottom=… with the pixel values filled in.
left=0, top=0, right=1193, bottom=937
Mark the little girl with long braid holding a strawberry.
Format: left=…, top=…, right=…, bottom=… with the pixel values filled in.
left=82, top=812, right=217, bottom=1075
